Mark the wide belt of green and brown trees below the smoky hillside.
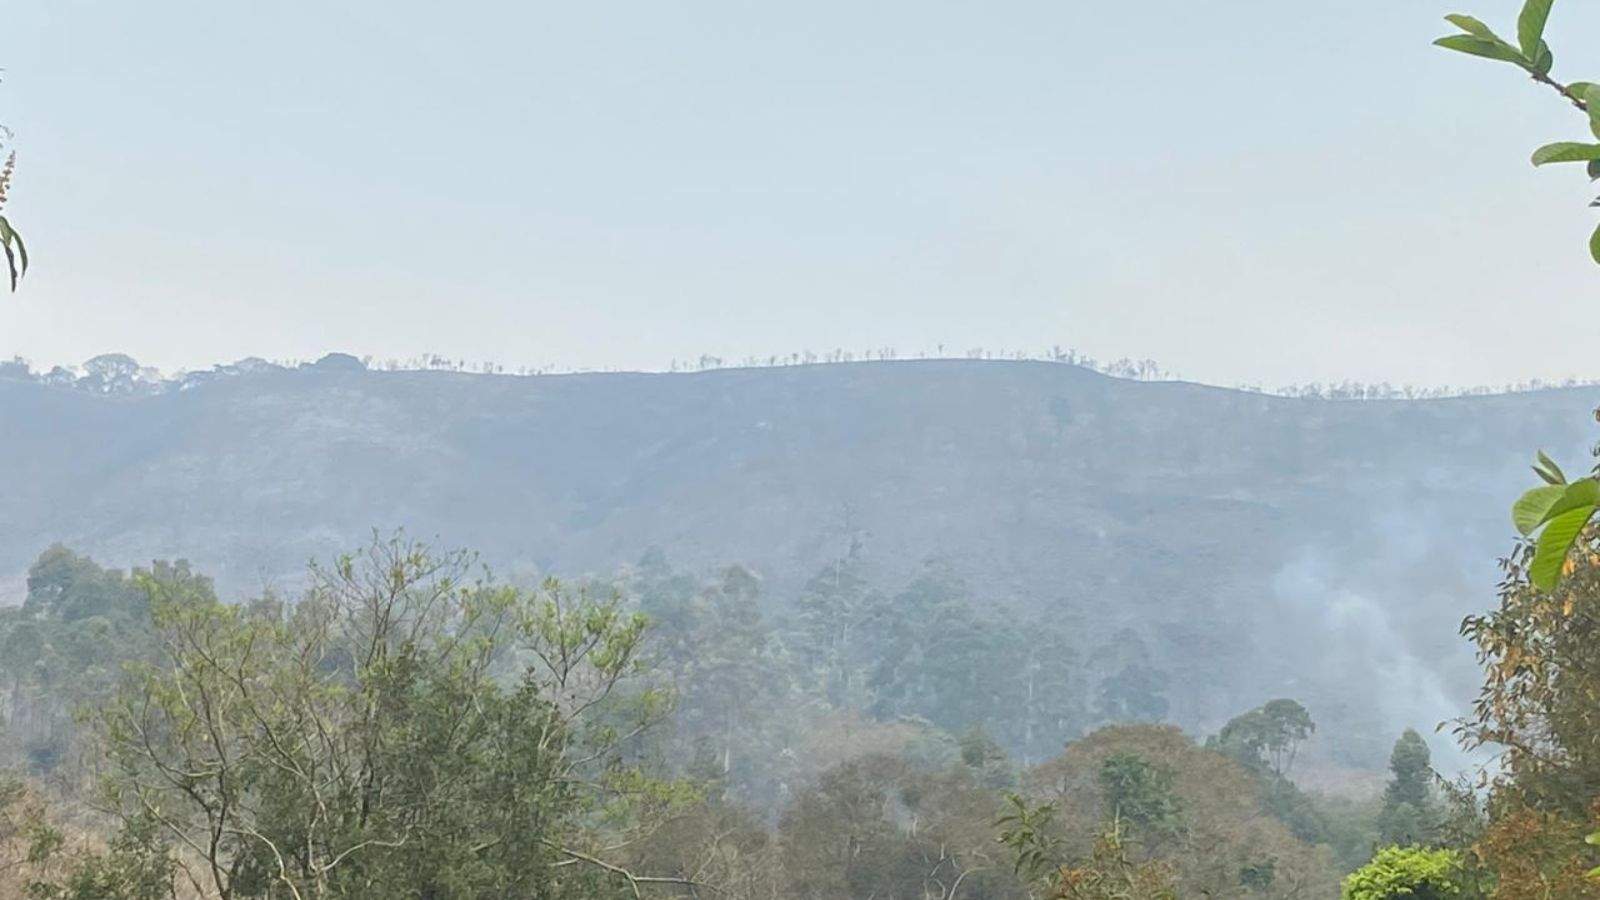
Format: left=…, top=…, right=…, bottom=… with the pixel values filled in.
left=0, top=535, right=1427, bottom=900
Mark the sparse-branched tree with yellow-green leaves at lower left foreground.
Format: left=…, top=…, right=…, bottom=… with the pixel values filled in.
left=68, top=538, right=694, bottom=900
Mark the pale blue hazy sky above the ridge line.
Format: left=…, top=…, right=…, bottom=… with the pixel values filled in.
left=0, top=0, right=1600, bottom=386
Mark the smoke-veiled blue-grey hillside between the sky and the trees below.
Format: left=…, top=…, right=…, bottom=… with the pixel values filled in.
left=0, top=353, right=1595, bottom=762
